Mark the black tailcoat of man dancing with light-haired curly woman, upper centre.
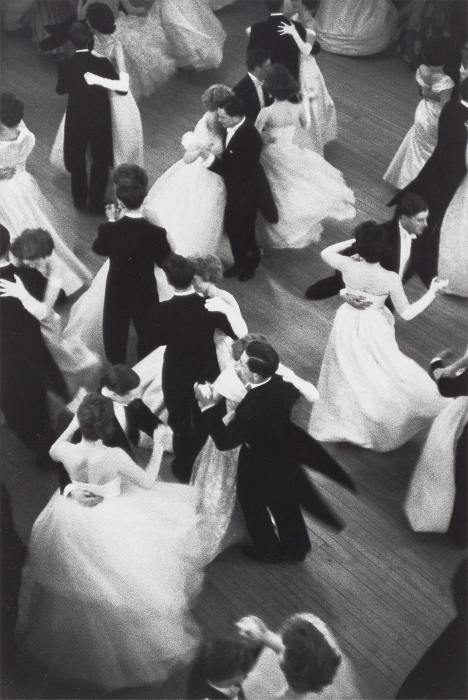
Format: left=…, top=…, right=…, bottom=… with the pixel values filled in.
left=210, top=119, right=278, bottom=223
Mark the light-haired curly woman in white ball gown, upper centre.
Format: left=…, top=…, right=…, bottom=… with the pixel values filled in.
left=144, top=85, right=233, bottom=257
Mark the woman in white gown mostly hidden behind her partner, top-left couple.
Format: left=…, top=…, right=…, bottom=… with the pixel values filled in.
left=50, top=2, right=143, bottom=169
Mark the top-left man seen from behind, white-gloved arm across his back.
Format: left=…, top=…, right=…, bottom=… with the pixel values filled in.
left=56, top=22, right=119, bottom=213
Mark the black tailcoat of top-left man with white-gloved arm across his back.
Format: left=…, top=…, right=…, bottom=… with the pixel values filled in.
left=56, top=51, right=119, bottom=171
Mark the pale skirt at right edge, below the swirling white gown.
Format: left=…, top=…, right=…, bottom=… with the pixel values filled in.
left=404, top=396, right=468, bottom=532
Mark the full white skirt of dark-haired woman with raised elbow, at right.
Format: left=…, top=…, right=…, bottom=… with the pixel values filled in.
left=309, top=303, right=449, bottom=452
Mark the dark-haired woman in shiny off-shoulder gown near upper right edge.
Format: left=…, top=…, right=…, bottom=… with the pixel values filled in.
left=383, top=37, right=455, bottom=189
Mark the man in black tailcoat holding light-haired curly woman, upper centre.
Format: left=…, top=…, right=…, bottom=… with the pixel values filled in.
left=204, top=96, right=278, bottom=282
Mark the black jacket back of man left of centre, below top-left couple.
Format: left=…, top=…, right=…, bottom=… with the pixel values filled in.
left=93, top=216, right=171, bottom=307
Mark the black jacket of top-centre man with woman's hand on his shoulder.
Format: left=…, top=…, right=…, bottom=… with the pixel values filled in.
left=247, top=15, right=307, bottom=80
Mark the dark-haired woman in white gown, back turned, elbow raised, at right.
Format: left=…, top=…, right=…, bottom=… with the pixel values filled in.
left=309, top=221, right=447, bottom=452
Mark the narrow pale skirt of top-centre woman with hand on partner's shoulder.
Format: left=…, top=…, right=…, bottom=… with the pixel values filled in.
left=298, top=54, right=338, bottom=155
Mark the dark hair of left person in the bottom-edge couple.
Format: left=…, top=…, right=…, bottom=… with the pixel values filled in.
left=199, top=639, right=260, bottom=683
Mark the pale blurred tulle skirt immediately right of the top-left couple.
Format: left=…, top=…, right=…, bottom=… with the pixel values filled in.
left=114, top=9, right=176, bottom=101
